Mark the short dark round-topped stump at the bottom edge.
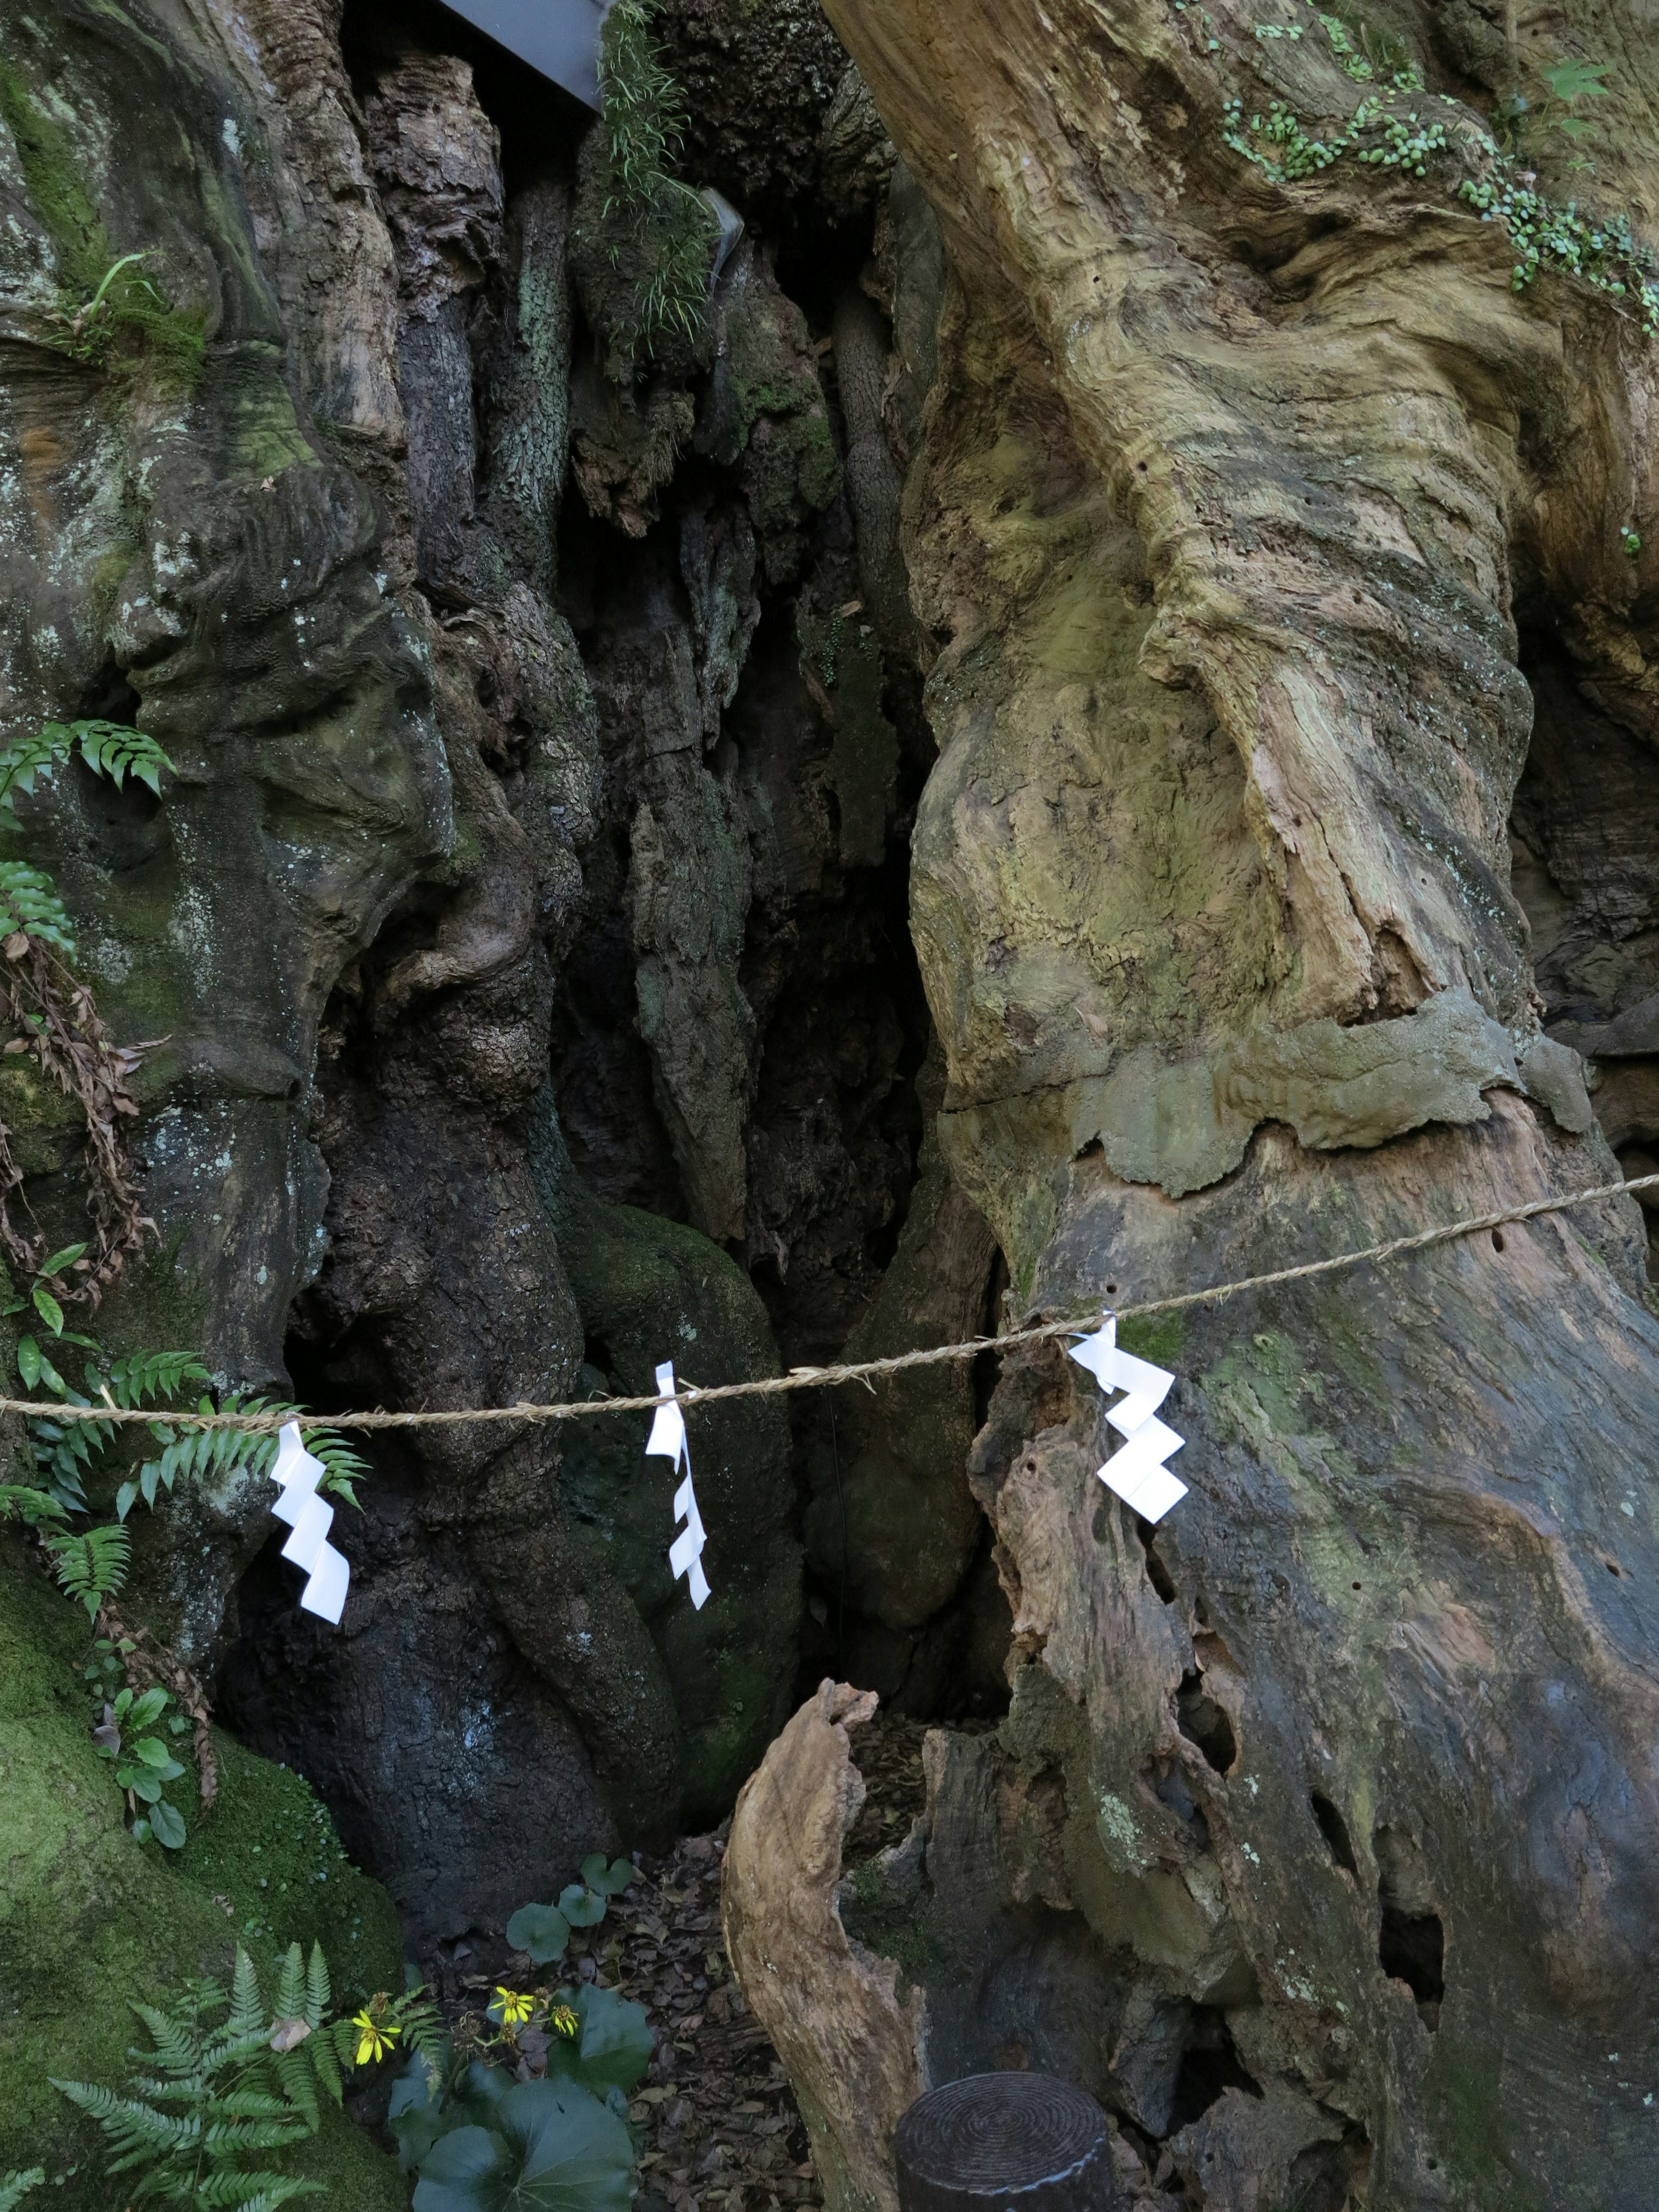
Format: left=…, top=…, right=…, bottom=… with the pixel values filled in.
left=893, top=2072, right=1117, bottom=2212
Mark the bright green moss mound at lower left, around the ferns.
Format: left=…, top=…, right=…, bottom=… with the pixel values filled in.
left=0, top=1535, right=407, bottom=2212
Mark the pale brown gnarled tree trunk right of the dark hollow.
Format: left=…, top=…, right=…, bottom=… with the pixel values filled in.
left=728, top=0, right=1659, bottom=2212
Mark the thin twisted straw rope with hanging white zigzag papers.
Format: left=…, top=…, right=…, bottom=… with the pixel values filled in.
left=0, top=1175, right=1659, bottom=1436
